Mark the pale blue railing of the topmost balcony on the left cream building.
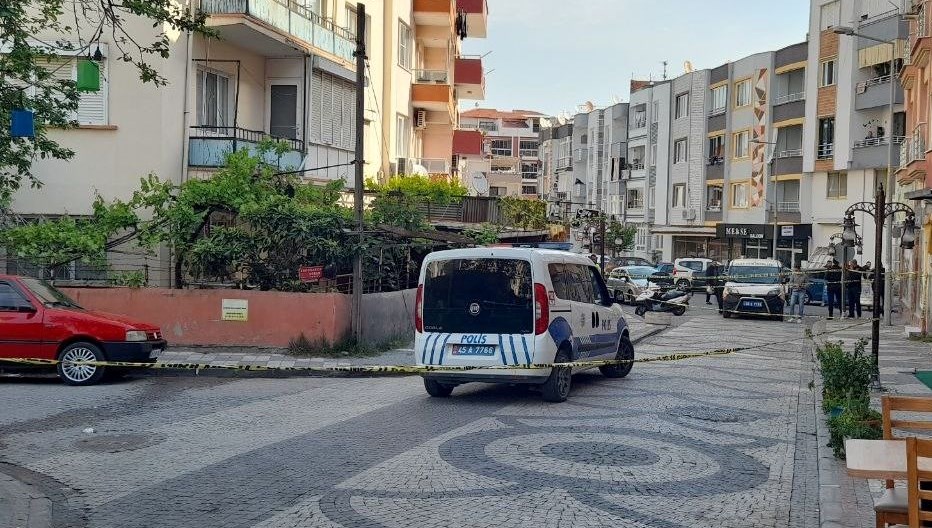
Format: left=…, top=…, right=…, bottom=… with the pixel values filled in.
left=201, top=0, right=356, bottom=62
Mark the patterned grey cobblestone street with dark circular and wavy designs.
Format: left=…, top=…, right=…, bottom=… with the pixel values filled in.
left=0, top=310, right=832, bottom=528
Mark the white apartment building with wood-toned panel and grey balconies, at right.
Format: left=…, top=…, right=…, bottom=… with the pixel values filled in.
left=803, top=0, right=907, bottom=269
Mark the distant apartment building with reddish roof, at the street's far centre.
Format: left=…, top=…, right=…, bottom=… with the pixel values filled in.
left=456, top=108, right=545, bottom=197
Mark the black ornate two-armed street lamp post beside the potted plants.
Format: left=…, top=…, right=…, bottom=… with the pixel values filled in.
left=842, top=191, right=916, bottom=389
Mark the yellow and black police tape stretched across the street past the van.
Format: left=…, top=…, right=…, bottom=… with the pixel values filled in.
left=0, top=319, right=872, bottom=374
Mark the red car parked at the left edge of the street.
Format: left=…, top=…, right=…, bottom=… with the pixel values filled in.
left=0, top=275, right=166, bottom=385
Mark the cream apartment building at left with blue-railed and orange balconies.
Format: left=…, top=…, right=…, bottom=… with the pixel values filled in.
left=13, top=0, right=488, bottom=284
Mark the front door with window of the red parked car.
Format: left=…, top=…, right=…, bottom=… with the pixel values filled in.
left=0, top=281, right=45, bottom=359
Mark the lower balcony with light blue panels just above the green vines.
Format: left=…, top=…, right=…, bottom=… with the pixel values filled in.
left=188, top=126, right=304, bottom=168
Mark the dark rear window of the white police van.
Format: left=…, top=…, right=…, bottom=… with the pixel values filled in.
left=424, top=258, right=534, bottom=334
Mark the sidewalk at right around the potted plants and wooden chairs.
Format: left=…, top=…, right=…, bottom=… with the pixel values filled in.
left=813, top=320, right=932, bottom=528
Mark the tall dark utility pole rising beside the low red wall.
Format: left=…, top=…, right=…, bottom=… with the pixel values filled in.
left=352, top=3, right=366, bottom=343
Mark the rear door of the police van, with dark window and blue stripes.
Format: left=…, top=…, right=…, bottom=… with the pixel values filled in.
left=418, top=257, right=534, bottom=365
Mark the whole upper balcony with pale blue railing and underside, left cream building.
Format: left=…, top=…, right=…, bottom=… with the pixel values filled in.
left=201, top=0, right=356, bottom=64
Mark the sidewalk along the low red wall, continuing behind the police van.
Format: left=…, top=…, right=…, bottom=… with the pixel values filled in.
left=158, top=307, right=669, bottom=372
